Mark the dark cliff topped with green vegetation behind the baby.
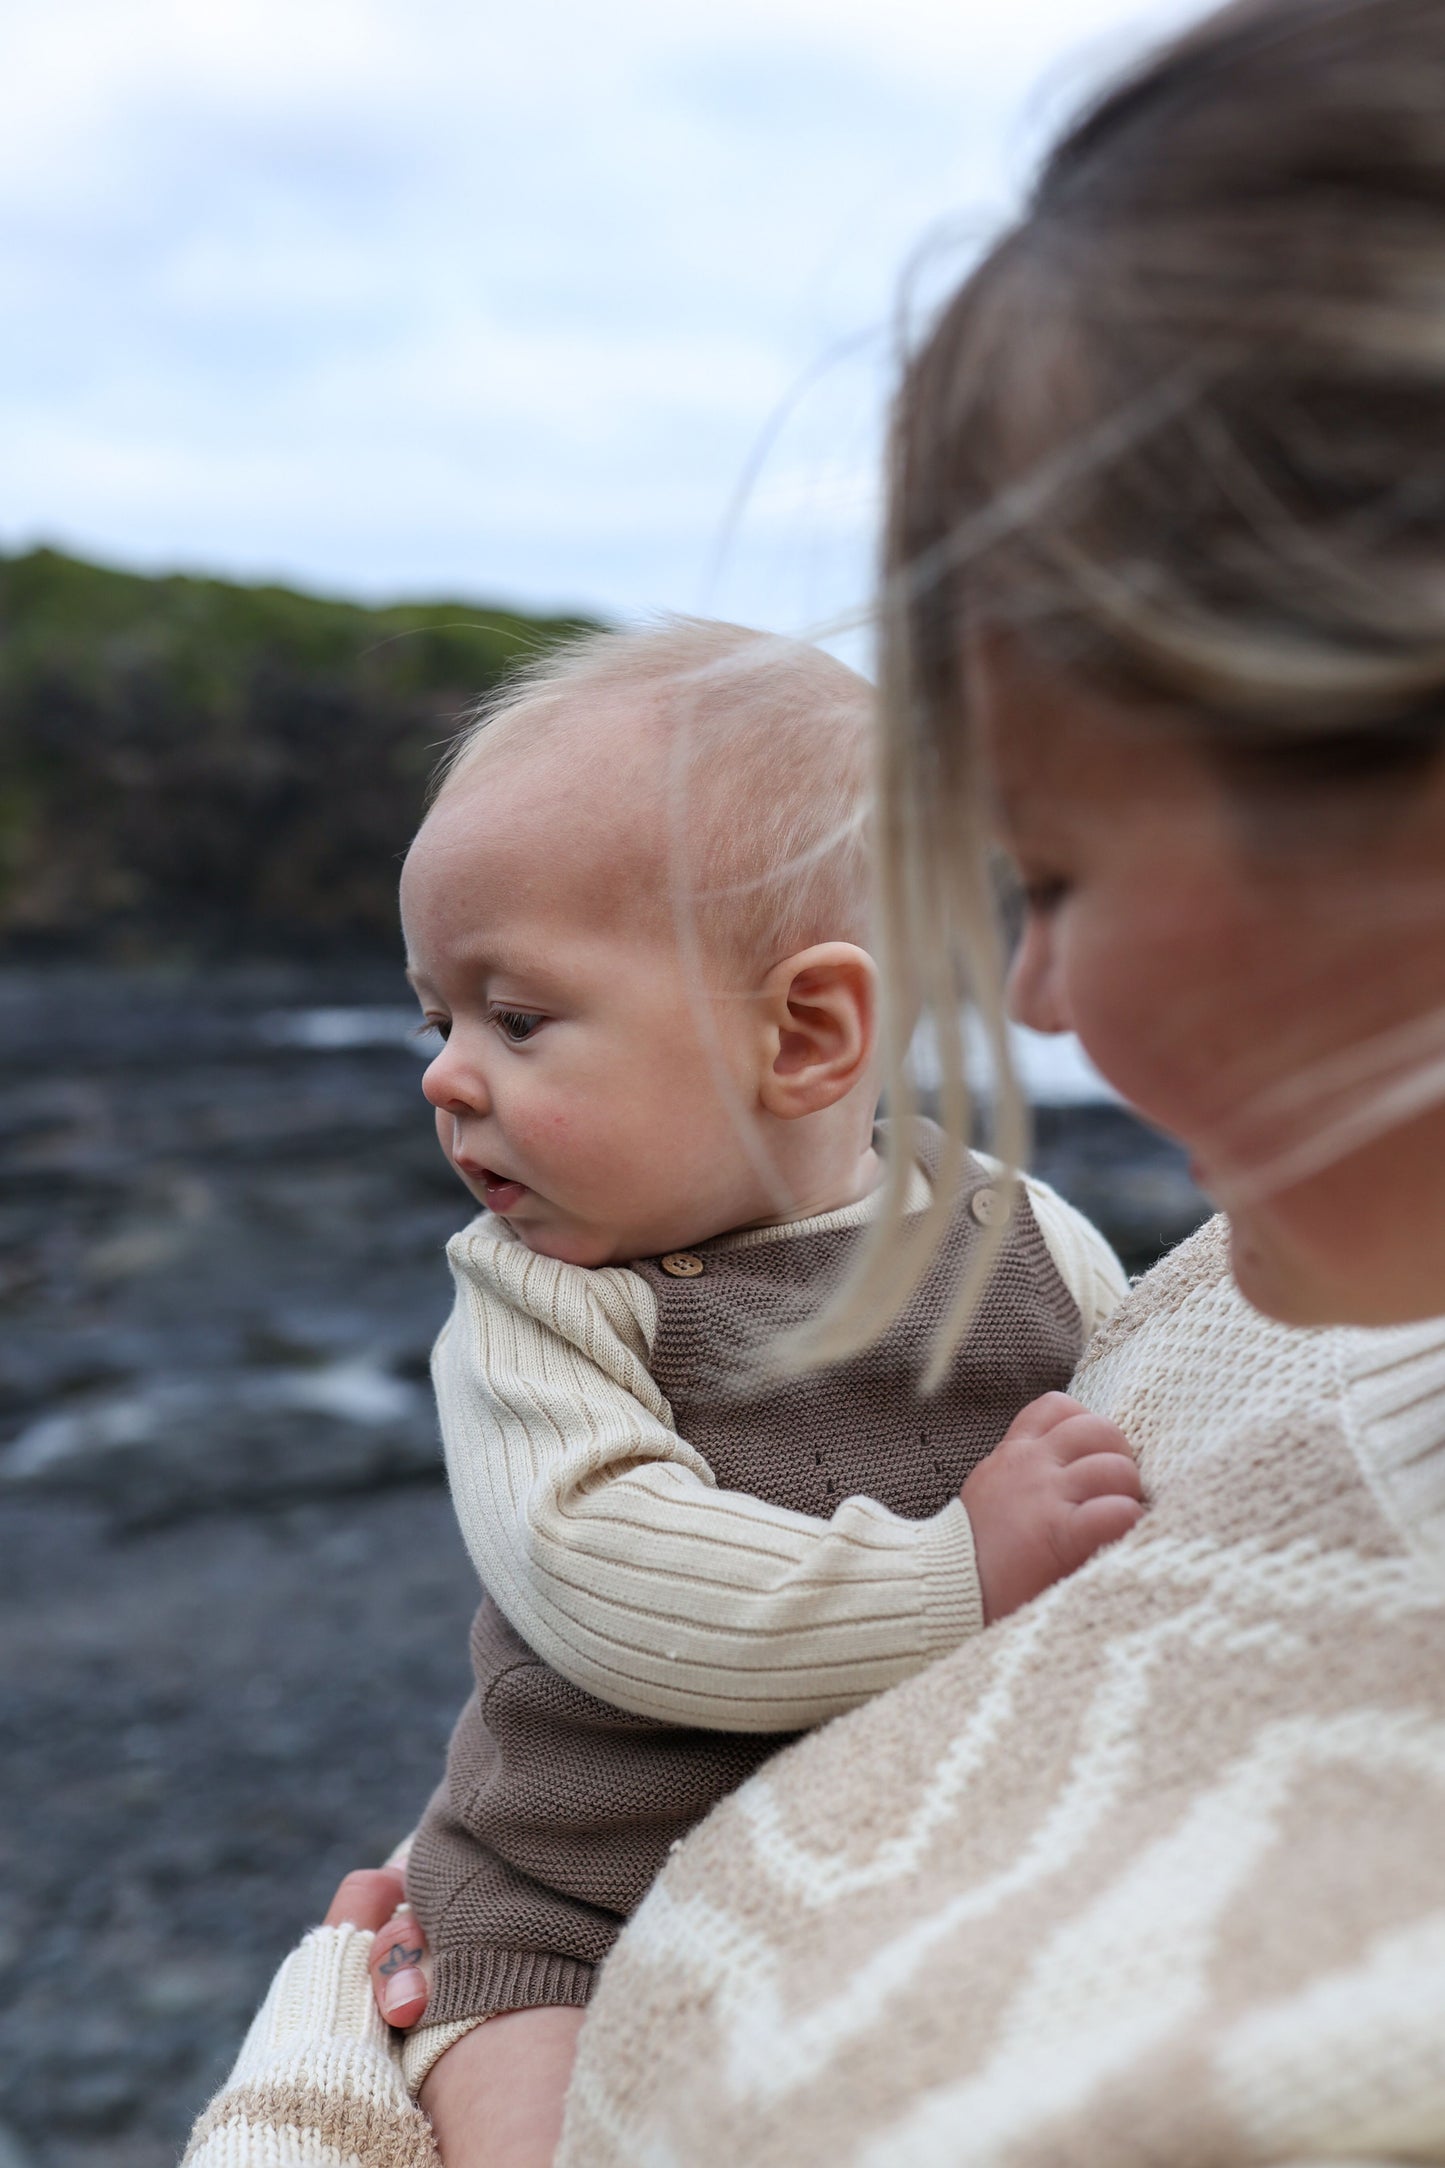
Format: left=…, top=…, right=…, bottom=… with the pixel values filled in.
left=0, top=549, right=597, bottom=956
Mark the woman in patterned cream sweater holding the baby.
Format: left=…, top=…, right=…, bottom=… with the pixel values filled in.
left=186, top=0, right=1445, bottom=2168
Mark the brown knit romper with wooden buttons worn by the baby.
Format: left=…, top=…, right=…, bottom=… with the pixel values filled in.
left=407, top=1125, right=1081, bottom=2023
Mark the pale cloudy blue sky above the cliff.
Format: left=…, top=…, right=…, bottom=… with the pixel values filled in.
left=0, top=0, right=1194, bottom=631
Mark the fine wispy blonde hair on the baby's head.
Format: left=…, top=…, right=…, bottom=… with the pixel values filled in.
left=433, top=616, right=873, bottom=978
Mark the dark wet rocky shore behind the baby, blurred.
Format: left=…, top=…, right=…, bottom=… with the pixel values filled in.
left=0, top=969, right=1205, bottom=2168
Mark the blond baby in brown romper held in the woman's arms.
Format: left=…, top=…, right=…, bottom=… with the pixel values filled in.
left=375, top=622, right=1140, bottom=2168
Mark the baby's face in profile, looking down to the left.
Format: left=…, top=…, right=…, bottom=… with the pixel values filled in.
left=401, top=754, right=776, bottom=1266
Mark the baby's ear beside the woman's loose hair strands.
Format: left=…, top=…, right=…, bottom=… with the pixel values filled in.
left=760, top=941, right=877, bottom=1121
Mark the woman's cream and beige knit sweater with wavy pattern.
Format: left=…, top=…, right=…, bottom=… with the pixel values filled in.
left=188, top=1225, right=1445, bottom=2168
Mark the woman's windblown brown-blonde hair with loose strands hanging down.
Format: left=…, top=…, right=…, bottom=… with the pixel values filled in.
left=810, top=0, right=1445, bottom=1375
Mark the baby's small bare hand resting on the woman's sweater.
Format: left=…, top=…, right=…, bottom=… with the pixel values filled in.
left=960, top=1392, right=1144, bottom=1624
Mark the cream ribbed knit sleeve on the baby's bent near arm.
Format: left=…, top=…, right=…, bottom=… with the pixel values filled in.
left=433, top=1223, right=984, bottom=1732
